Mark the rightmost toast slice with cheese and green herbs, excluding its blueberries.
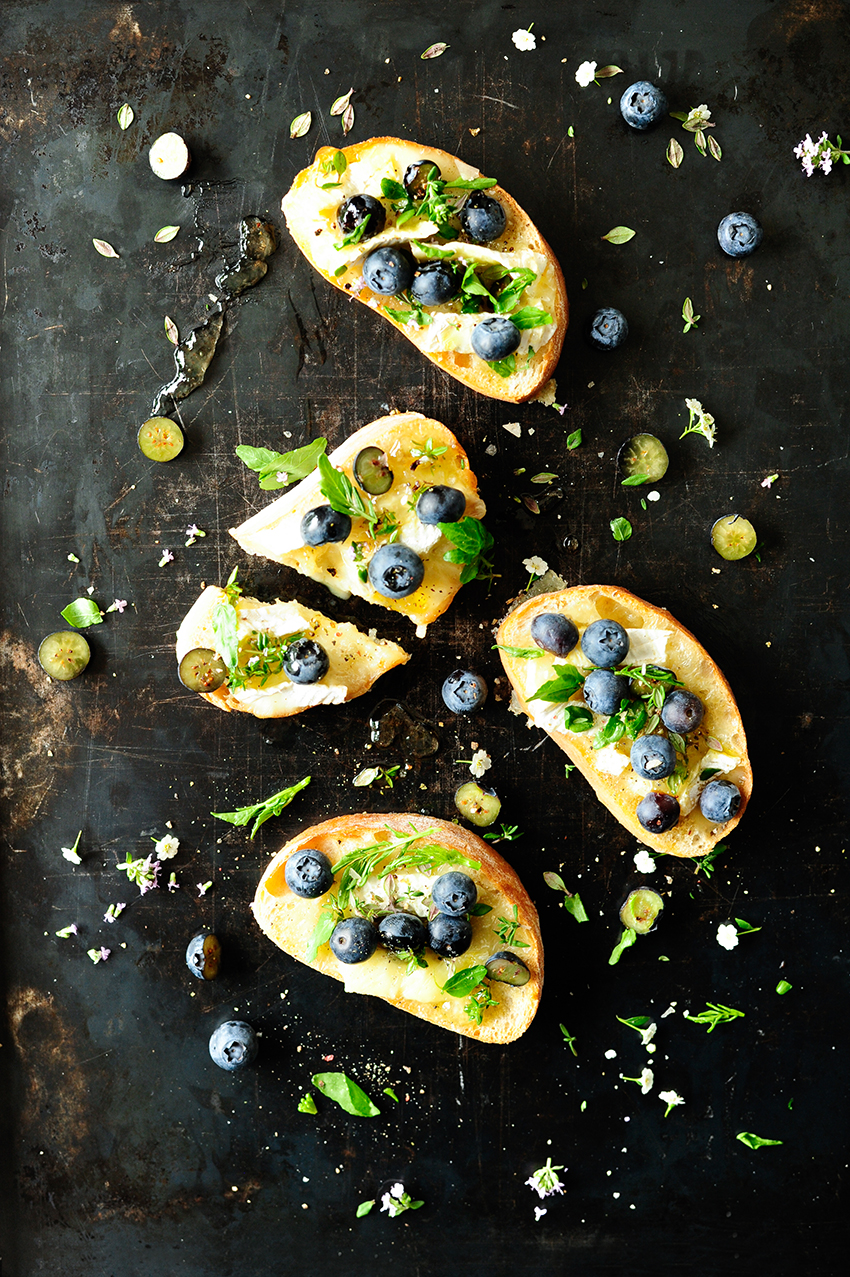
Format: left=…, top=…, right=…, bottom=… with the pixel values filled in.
left=496, top=585, right=753, bottom=857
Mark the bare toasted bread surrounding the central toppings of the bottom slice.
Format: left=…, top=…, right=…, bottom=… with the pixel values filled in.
left=251, top=812, right=544, bottom=1045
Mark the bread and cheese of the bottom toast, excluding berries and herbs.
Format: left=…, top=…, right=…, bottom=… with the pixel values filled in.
left=251, top=813, right=544, bottom=1043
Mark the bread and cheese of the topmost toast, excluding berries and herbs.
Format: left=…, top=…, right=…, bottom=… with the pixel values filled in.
left=282, top=138, right=569, bottom=404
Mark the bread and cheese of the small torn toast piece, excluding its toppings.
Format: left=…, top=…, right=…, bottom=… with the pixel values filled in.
left=177, top=585, right=410, bottom=719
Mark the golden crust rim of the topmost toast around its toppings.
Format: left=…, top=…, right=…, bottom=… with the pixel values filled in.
left=281, top=138, right=569, bottom=404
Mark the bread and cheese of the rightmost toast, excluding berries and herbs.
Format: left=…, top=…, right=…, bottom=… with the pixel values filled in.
left=496, top=585, right=753, bottom=856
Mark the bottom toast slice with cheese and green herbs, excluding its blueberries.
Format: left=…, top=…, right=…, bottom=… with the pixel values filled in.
left=251, top=812, right=544, bottom=1043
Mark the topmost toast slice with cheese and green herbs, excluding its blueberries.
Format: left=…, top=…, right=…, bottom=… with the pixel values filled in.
left=282, top=138, right=569, bottom=404
